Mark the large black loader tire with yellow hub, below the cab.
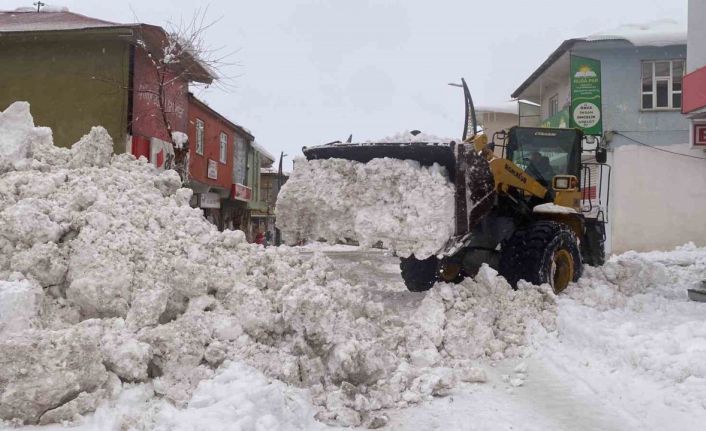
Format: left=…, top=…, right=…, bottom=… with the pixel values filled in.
left=500, top=221, right=583, bottom=293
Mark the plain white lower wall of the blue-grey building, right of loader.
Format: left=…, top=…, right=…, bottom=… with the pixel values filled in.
left=612, top=144, right=706, bottom=253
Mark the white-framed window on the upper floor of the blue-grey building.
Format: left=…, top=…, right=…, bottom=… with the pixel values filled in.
left=642, top=60, right=684, bottom=109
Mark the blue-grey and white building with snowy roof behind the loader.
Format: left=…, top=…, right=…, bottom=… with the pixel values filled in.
left=512, top=20, right=706, bottom=253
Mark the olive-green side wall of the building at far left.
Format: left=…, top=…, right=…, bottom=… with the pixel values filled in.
left=0, top=32, right=130, bottom=153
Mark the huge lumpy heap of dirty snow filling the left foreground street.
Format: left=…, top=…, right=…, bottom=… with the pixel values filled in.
left=0, top=103, right=555, bottom=429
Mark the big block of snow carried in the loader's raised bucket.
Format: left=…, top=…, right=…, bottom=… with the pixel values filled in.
left=276, top=158, right=455, bottom=259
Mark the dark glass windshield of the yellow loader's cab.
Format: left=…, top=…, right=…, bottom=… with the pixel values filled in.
left=507, top=127, right=581, bottom=186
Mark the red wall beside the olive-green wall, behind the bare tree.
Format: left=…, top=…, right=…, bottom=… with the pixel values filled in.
left=132, top=47, right=189, bottom=142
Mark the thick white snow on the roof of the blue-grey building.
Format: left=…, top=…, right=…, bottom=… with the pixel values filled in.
left=586, top=19, right=686, bottom=46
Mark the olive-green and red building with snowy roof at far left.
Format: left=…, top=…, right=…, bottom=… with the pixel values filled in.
left=0, top=9, right=213, bottom=173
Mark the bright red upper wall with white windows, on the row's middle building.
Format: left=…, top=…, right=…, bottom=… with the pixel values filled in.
left=187, top=100, right=235, bottom=192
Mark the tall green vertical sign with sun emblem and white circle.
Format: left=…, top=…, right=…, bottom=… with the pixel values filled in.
left=570, top=55, right=603, bottom=135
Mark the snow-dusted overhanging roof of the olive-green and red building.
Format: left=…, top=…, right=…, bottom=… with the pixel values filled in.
left=0, top=9, right=215, bottom=84
